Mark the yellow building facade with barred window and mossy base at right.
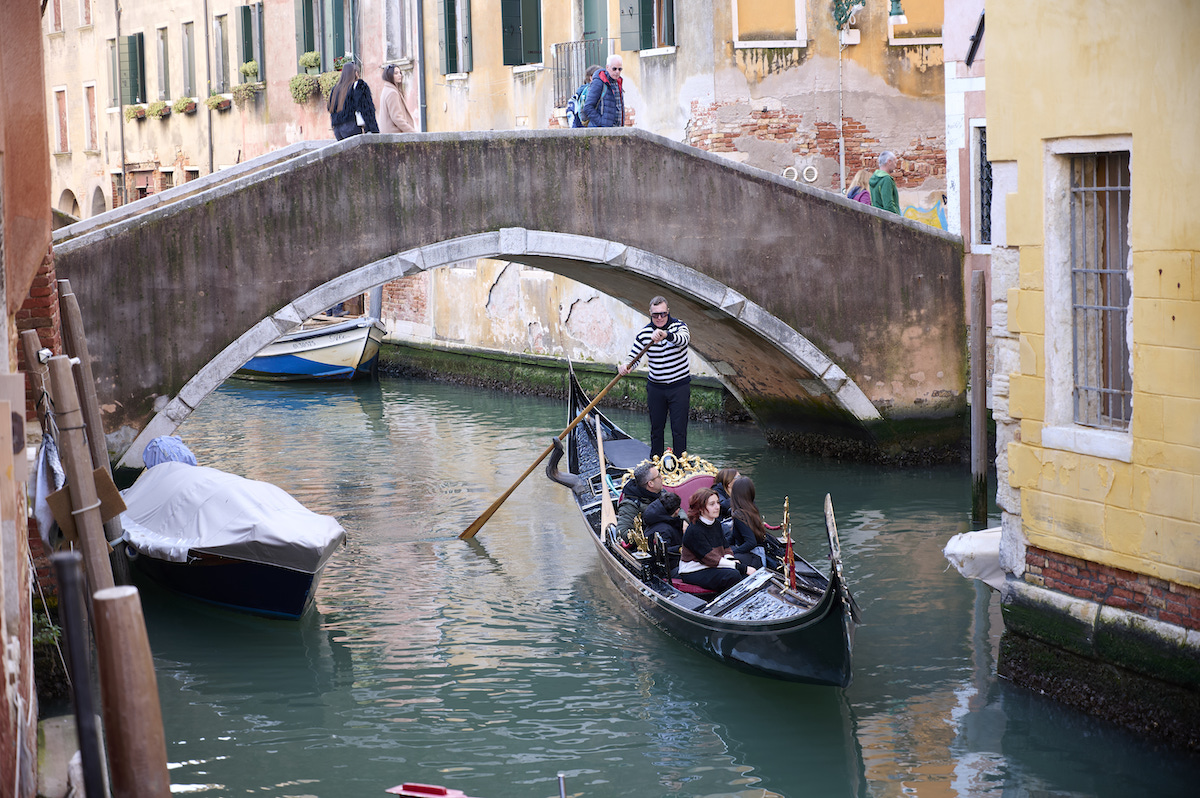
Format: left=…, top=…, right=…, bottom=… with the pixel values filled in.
left=986, top=0, right=1200, bottom=737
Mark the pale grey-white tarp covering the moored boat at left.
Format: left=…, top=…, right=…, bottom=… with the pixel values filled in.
left=121, top=462, right=346, bottom=574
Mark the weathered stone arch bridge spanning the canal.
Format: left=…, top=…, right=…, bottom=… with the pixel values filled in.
left=54, top=128, right=966, bottom=467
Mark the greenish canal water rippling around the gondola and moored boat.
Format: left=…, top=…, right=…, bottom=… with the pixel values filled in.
left=143, top=379, right=1200, bottom=798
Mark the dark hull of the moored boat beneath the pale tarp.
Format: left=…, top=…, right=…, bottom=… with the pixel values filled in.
left=132, top=553, right=324, bottom=619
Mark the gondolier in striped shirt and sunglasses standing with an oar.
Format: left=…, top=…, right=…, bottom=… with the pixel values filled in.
left=617, top=296, right=691, bottom=457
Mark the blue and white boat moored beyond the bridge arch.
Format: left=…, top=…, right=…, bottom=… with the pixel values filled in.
left=233, top=316, right=384, bottom=382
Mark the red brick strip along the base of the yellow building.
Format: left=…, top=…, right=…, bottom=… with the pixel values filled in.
left=1025, top=546, right=1200, bottom=631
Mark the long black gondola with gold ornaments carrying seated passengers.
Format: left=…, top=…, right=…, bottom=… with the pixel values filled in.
left=546, top=370, right=859, bottom=688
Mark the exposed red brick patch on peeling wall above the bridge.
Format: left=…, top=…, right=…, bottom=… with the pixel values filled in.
left=684, top=100, right=946, bottom=190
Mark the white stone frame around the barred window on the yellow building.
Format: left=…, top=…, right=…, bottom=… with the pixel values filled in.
left=1042, top=134, right=1136, bottom=463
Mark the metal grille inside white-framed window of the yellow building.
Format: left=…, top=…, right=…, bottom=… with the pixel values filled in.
left=1070, top=152, right=1133, bottom=430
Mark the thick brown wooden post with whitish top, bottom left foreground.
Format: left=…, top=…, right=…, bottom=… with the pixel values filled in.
left=92, top=584, right=170, bottom=798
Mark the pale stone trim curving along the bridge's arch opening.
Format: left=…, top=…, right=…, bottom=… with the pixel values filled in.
left=120, top=228, right=880, bottom=468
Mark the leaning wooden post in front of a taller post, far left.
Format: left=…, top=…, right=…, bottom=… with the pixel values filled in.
left=50, top=355, right=113, bottom=592
